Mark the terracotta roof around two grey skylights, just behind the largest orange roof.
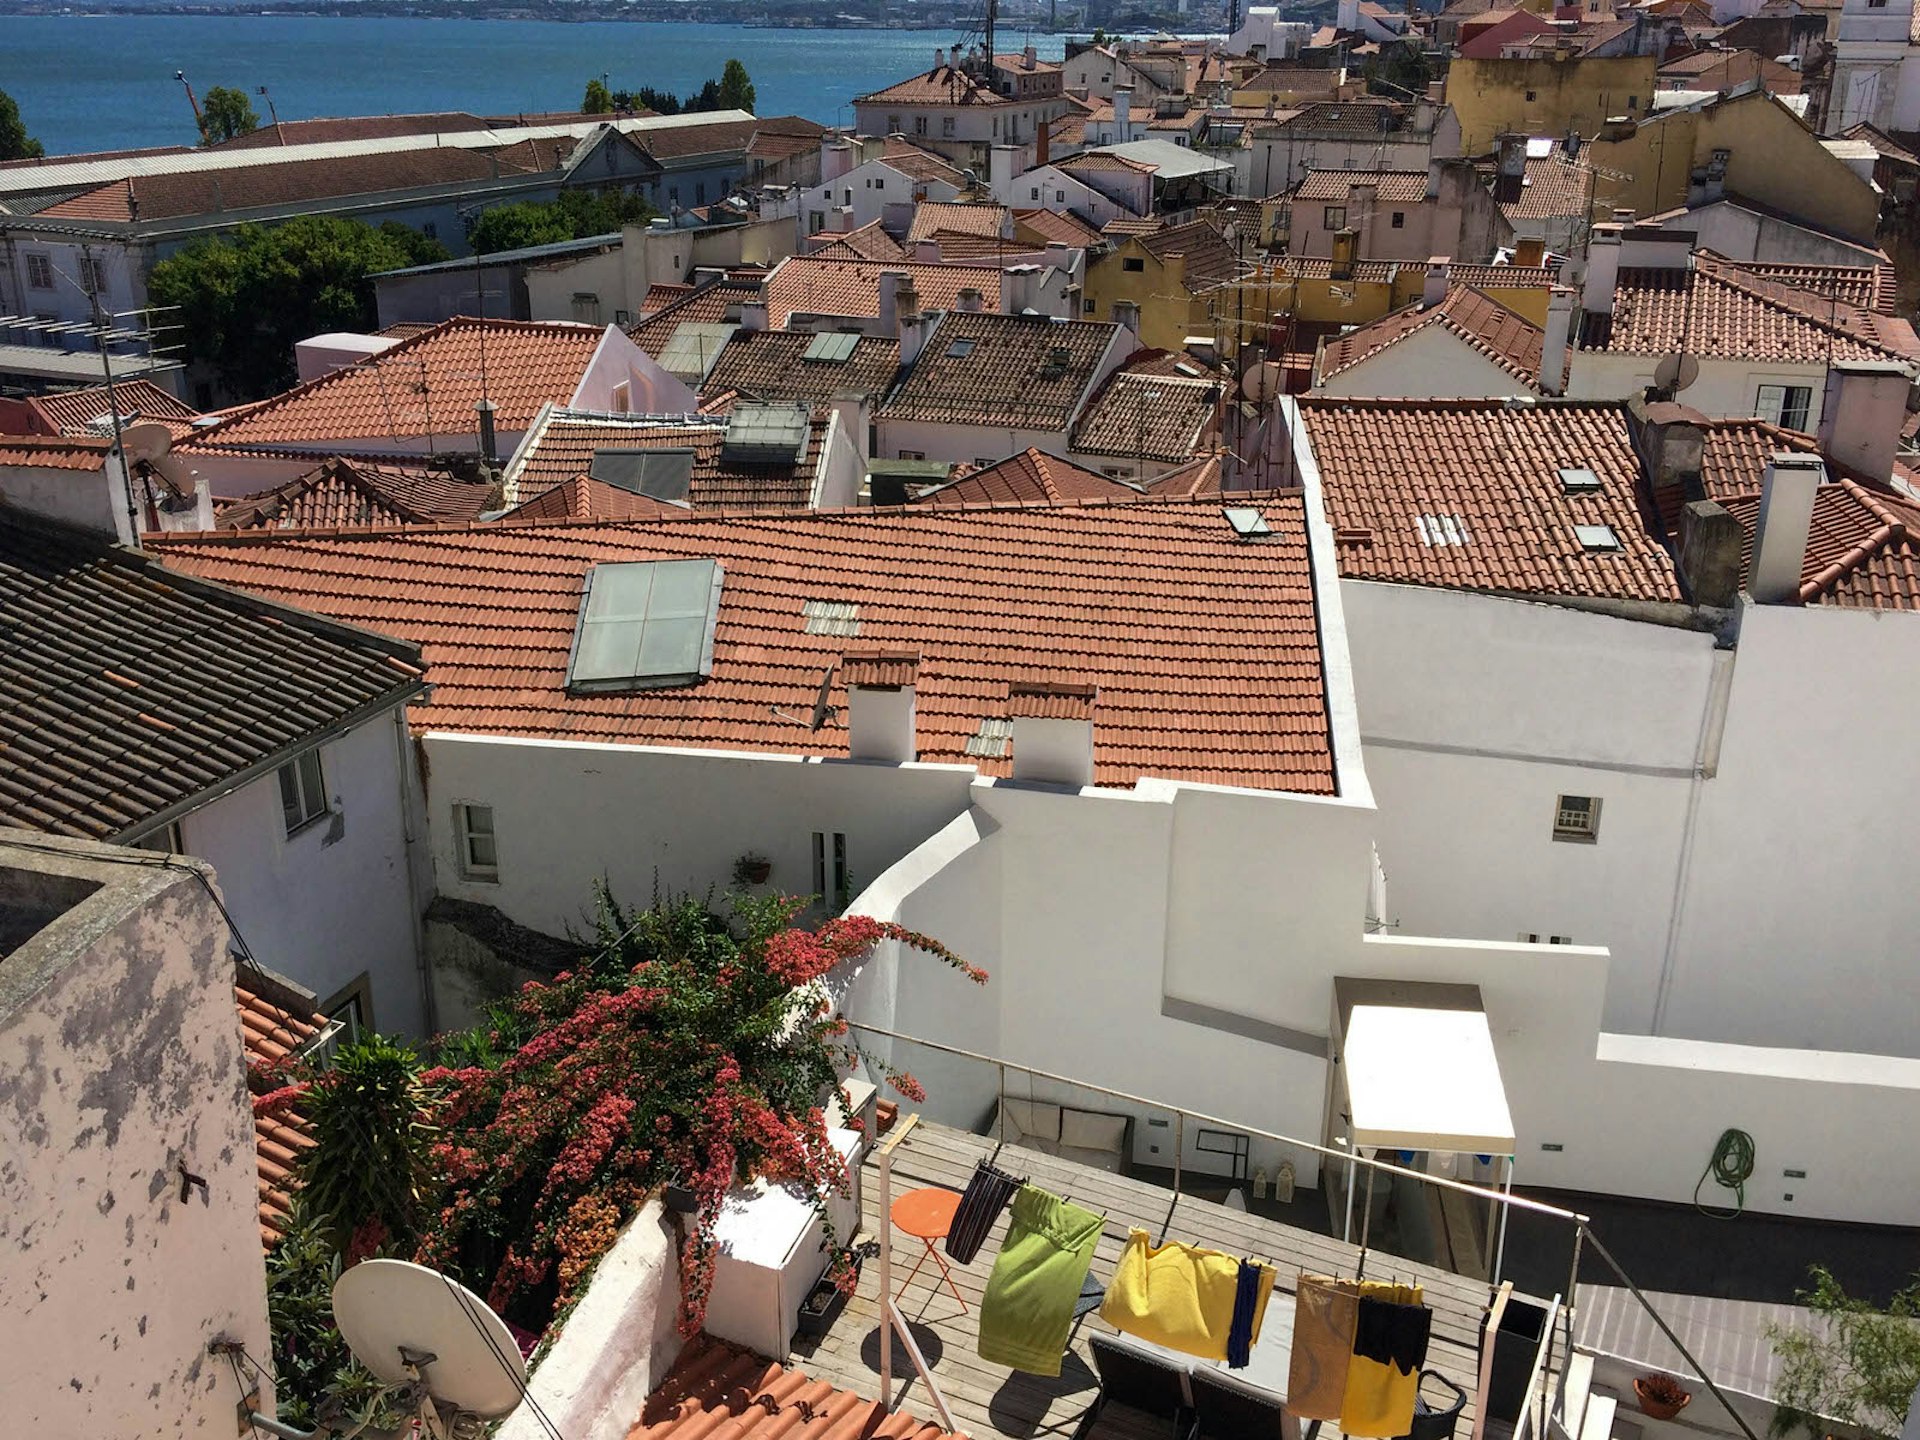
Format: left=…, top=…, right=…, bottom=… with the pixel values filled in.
left=505, top=407, right=831, bottom=518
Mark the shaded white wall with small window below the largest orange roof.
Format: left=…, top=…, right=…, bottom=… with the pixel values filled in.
left=422, top=726, right=973, bottom=935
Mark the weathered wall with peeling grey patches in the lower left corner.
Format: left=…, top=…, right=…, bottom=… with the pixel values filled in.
left=0, top=837, right=273, bottom=1440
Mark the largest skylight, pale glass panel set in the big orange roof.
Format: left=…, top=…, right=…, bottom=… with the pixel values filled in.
left=566, top=561, right=722, bottom=693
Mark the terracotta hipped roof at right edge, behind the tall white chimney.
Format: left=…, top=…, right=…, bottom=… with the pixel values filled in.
left=1720, top=476, right=1920, bottom=611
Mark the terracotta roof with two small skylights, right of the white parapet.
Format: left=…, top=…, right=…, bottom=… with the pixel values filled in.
left=1300, top=396, right=1684, bottom=603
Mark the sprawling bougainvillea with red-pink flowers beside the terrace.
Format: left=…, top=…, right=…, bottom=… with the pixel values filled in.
left=417, top=891, right=987, bottom=1334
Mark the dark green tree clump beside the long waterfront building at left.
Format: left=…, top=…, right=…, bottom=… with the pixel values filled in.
left=148, top=215, right=447, bottom=399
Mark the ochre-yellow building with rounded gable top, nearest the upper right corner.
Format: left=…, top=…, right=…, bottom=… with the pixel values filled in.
left=1582, top=90, right=1880, bottom=246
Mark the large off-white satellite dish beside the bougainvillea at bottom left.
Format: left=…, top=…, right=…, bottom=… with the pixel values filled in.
left=334, top=1260, right=526, bottom=1434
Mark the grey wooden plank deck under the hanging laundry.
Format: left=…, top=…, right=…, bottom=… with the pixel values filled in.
left=789, top=1123, right=1543, bottom=1440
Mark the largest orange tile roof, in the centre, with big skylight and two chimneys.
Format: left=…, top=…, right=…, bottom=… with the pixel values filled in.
left=154, top=493, right=1334, bottom=793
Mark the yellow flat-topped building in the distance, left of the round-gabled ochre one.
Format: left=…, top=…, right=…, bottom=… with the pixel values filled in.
left=1446, top=54, right=1655, bottom=156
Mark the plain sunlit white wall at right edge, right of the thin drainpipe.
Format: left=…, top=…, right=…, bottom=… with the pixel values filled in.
left=1665, top=605, right=1920, bottom=1056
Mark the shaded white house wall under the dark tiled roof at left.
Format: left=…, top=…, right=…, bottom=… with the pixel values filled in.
left=180, top=712, right=426, bottom=1035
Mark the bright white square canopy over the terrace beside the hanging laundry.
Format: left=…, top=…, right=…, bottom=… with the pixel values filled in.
left=1342, top=1004, right=1513, bottom=1156
